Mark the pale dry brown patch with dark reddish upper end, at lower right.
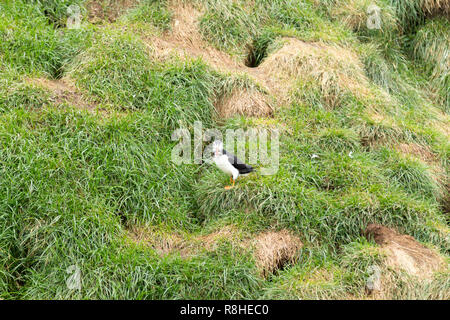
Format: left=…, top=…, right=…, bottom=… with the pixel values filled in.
left=365, top=224, right=444, bottom=279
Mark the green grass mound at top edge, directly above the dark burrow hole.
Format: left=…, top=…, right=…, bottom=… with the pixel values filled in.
left=196, top=0, right=354, bottom=60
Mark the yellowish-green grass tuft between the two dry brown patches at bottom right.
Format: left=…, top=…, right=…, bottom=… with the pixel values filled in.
left=264, top=242, right=382, bottom=300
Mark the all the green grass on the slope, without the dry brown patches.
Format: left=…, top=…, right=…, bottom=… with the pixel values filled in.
left=0, top=0, right=450, bottom=299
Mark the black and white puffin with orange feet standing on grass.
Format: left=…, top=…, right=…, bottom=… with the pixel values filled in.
left=213, top=140, right=255, bottom=190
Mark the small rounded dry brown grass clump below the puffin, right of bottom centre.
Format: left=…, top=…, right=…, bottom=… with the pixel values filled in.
left=253, top=230, right=303, bottom=277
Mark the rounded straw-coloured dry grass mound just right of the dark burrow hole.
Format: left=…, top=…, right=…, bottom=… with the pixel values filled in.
left=257, top=38, right=370, bottom=104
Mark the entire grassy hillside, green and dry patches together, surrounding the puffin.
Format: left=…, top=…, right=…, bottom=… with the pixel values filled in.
left=0, top=0, right=450, bottom=299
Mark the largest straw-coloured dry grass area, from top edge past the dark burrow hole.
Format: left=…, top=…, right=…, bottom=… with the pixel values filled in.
left=144, top=4, right=372, bottom=117
